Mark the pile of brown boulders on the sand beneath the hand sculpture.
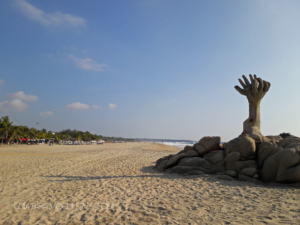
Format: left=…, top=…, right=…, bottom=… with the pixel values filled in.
left=155, top=134, right=300, bottom=183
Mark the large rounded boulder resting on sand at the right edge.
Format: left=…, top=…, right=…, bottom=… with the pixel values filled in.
left=260, top=148, right=300, bottom=182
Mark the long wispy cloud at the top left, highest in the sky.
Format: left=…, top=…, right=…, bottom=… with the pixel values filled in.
left=16, top=0, right=85, bottom=27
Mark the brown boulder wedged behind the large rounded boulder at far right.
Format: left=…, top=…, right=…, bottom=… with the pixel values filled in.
left=257, top=140, right=283, bottom=168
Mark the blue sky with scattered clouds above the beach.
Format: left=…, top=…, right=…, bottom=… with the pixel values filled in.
left=0, top=0, right=300, bottom=141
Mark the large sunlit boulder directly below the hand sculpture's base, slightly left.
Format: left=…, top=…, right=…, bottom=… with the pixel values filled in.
left=226, top=136, right=256, bottom=160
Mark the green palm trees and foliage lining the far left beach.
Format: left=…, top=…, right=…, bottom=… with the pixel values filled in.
left=0, top=116, right=134, bottom=145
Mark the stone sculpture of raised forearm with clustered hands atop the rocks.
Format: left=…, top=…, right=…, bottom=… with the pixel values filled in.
left=234, top=74, right=271, bottom=136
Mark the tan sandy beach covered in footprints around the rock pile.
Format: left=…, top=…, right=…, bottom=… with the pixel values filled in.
left=0, top=143, right=300, bottom=225
